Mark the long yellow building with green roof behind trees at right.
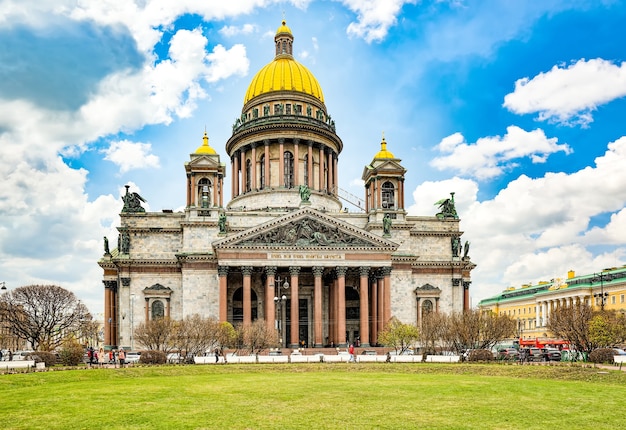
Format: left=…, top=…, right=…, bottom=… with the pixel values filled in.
left=478, top=265, right=626, bottom=339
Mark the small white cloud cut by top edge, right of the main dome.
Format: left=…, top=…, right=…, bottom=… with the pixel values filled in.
left=342, top=0, right=416, bottom=43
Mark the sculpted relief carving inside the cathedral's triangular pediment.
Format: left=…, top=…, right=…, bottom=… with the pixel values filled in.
left=240, top=218, right=376, bottom=247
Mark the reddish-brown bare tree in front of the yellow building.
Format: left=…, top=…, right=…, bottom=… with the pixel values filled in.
left=546, top=303, right=597, bottom=352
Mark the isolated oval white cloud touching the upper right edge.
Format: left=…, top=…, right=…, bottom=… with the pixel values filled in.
left=504, top=58, right=626, bottom=126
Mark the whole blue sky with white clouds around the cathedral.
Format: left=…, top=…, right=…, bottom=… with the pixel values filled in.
left=0, top=0, right=626, bottom=315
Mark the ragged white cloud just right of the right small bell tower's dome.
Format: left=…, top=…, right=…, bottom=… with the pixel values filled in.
left=430, top=126, right=571, bottom=179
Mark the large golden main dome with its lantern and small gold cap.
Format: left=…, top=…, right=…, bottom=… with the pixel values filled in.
left=243, top=20, right=324, bottom=105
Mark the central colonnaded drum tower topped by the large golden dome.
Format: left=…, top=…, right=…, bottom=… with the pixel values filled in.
left=226, top=21, right=343, bottom=212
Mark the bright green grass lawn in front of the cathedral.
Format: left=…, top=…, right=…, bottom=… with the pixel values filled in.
left=0, top=363, right=626, bottom=429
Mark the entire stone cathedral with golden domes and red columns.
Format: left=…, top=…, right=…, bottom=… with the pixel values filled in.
left=98, top=21, right=475, bottom=348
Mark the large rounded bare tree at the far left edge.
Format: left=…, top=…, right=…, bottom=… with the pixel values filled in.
left=0, top=285, right=89, bottom=351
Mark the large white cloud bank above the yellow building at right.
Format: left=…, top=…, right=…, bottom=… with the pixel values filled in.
left=409, top=137, right=626, bottom=297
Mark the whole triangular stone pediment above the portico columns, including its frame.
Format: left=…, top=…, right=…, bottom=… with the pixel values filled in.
left=213, top=208, right=398, bottom=252
